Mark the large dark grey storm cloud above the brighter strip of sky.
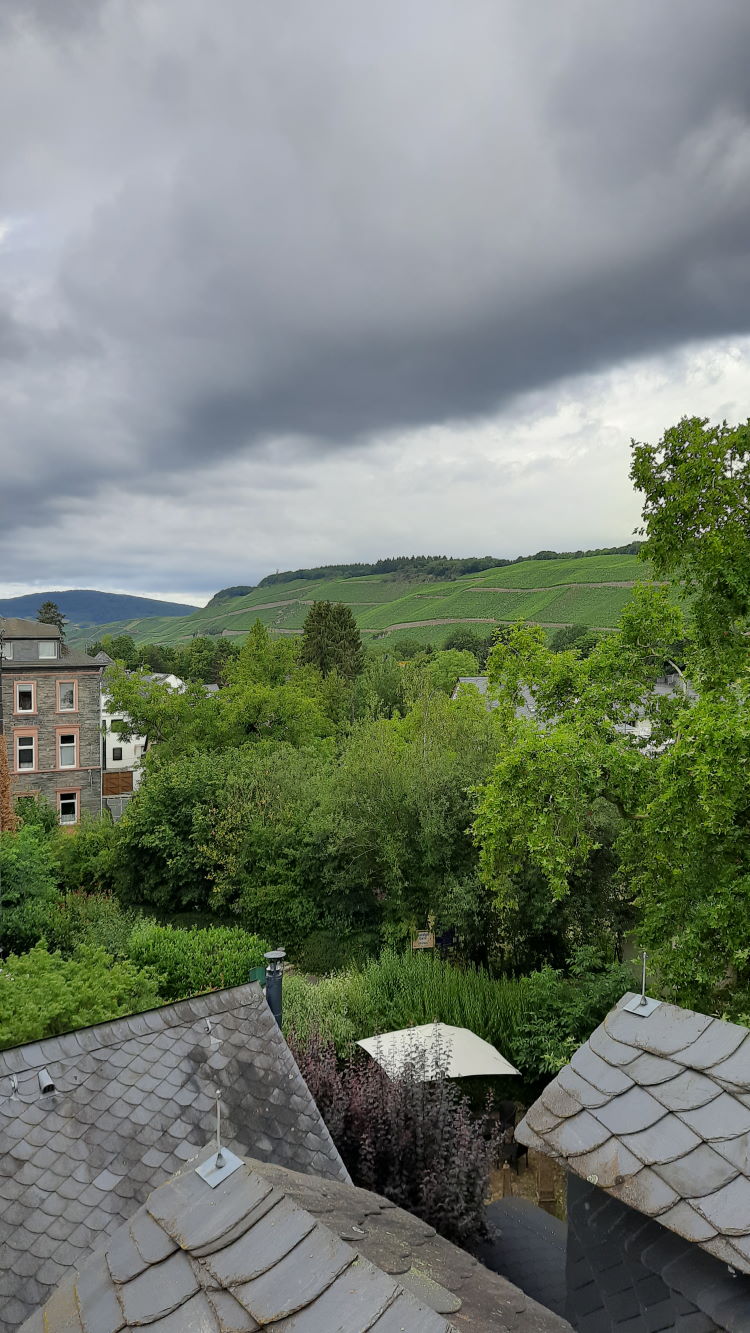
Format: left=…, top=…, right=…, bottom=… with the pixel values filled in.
left=0, top=0, right=750, bottom=573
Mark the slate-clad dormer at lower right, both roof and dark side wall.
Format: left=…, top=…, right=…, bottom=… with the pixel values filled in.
left=516, top=994, right=750, bottom=1333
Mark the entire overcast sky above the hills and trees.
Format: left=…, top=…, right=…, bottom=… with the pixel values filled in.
left=0, top=0, right=750, bottom=599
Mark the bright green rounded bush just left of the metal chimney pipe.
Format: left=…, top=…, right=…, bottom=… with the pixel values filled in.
left=128, top=921, right=270, bottom=1000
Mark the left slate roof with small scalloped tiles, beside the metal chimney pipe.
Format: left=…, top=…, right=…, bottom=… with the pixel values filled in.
left=0, top=984, right=349, bottom=1333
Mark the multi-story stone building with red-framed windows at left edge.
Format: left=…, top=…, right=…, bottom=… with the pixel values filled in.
left=0, top=620, right=103, bottom=824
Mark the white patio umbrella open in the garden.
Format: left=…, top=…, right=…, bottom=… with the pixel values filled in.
left=357, top=1022, right=518, bottom=1082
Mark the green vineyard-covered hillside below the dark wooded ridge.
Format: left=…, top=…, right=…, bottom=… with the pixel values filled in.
left=68, top=556, right=658, bottom=644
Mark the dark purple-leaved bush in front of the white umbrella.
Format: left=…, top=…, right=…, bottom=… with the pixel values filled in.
left=290, top=1033, right=496, bottom=1245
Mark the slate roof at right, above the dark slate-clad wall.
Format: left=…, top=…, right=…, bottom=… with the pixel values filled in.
left=516, top=994, right=750, bottom=1273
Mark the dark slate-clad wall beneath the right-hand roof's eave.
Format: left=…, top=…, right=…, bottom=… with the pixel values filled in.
left=565, top=1174, right=750, bottom=1333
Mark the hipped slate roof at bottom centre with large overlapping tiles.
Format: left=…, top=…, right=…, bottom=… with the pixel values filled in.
left=23, top=1149, right=569, bottom=1333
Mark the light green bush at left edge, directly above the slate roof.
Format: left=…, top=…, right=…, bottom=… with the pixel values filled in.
left=0, top=945, right=159, bottom=1049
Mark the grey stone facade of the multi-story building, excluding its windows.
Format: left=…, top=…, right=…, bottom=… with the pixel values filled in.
left=0, top=671, right=101, bottom=814
